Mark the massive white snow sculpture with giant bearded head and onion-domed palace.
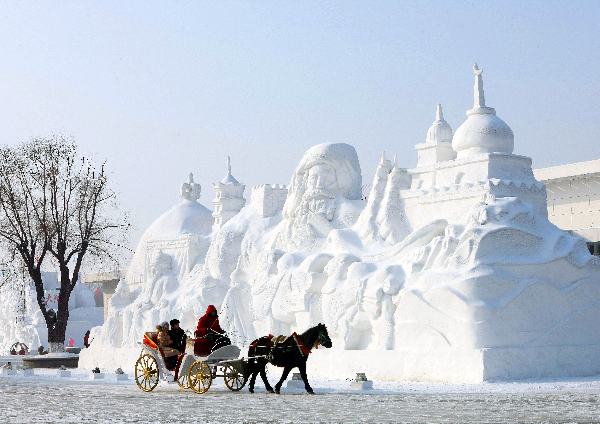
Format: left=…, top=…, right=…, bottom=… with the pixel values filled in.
left=80, top=65, right=600, bottom=382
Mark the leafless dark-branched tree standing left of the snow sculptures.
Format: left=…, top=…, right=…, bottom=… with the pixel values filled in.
left=0, top=136, right=129, bottom=352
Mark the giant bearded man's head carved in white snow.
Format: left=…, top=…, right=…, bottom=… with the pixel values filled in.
left=271, top=143, right=362, bottom=252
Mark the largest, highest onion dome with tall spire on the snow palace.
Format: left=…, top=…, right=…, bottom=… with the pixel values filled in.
left=452, top=64, right=515, bottom=159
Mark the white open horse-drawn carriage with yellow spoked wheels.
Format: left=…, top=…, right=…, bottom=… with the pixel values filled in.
left=135, top=332, right=248, bottom=394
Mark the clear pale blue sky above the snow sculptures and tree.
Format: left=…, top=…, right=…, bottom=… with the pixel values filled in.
left=0, top=1, right=600, bottom=250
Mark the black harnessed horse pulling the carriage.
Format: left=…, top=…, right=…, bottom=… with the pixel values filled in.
left=248, top=324, right=331, bottom=394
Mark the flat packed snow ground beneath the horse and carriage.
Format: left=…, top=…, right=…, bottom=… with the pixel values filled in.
left=0, top=369, right=600, bottom=423
